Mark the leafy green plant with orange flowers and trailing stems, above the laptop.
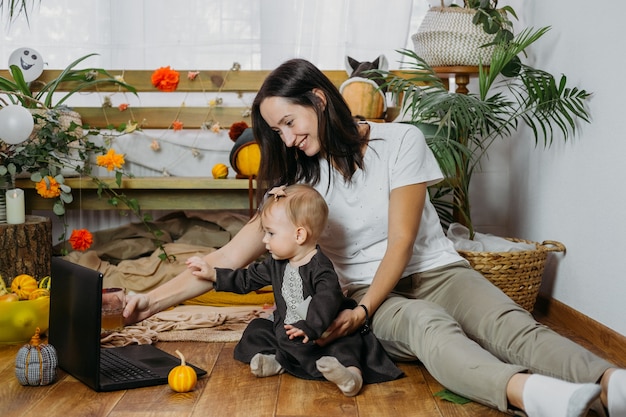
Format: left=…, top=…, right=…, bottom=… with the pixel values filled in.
left=0, top=54, right=169, bottom=259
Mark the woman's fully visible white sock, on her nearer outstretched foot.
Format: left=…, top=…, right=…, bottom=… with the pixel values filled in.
left=523, top=374, right=601, bottom=417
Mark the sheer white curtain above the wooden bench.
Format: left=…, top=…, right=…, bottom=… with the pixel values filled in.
left=0, top=0, right=428, bottom=70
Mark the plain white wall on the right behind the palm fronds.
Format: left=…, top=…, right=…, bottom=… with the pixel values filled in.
left=474, top=0, right=626, bottom=335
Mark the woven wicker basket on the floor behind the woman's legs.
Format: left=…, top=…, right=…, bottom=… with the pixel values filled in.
left=458, top=238, right=565, bottom=311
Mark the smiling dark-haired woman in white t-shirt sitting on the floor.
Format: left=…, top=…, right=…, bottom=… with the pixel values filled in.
left=125, top=59, right=626, bottom=417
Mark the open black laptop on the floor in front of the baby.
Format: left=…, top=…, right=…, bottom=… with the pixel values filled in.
left=48, top=257, right=207, bottom=391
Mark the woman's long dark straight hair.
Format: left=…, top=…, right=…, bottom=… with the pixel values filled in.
left=252, top=59, right=367, bottom=200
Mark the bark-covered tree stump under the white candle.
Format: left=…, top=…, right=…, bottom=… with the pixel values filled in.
left=0, top=216, right=52, bottom=288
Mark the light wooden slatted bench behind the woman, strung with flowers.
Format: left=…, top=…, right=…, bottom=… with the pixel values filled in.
left=0, top=70, right=450, bottom=211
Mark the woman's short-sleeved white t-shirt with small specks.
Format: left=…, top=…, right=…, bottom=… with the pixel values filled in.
left=315, top=123, right=463, bottom=287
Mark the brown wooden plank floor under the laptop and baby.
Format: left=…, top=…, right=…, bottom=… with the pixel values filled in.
left=0, top=310, right=610, bottom=417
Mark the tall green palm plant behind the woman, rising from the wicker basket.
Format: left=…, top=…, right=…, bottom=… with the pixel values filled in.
left=380, top=27, right=590, bottom=238
